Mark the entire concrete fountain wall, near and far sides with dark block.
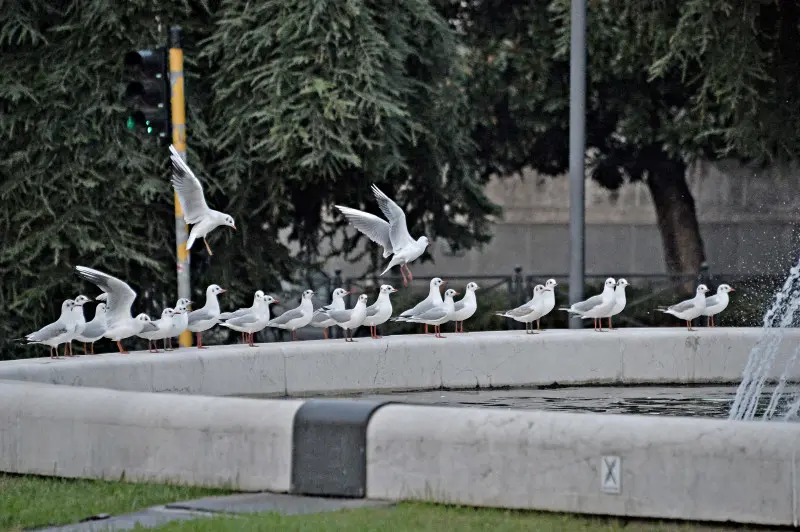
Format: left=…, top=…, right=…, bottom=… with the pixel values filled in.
left=0, top=328, right=800, bottom=526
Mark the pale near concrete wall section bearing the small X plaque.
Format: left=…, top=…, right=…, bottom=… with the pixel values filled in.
left=367, top=405, right=800, bottom=526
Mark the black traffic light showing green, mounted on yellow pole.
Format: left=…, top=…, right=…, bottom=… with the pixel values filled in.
left=125, top=48, right=172, bottom=144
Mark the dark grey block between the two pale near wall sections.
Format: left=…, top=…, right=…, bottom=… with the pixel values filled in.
left=289, top=399, right=393, bottom=498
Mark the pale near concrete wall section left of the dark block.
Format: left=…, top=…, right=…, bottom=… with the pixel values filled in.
left=0, top=381, right=302, bottom=492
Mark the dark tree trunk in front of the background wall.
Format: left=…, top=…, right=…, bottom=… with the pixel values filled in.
left=646, top=154, right=706, bottom=291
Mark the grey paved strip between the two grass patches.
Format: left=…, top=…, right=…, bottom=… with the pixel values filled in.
left=39, top=493, right=392, bottom=532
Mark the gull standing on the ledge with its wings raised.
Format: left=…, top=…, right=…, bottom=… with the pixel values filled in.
left=75, top=266, right=157, bottom=354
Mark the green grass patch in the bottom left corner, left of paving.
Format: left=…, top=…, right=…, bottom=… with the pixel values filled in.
left=0, top=473, right=230, bottom=530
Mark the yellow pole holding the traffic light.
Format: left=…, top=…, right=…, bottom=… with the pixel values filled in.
left=169, top=26, right=192, bottom=347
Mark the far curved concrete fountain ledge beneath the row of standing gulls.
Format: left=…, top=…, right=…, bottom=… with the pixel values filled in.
left=0, top=328, right=800, bottom=396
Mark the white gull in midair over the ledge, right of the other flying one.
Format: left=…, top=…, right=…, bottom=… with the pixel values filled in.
left=335, top=185, right=429, bottom=286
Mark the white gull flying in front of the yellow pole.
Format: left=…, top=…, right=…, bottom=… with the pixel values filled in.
left=169, top=145, right=236, bottom=255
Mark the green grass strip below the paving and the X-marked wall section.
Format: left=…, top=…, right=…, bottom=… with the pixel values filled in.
left=154, top=503, right=760, bottom=532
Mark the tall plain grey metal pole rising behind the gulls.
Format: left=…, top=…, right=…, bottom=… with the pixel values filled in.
left=569, top=0, right=586, bottom=329
